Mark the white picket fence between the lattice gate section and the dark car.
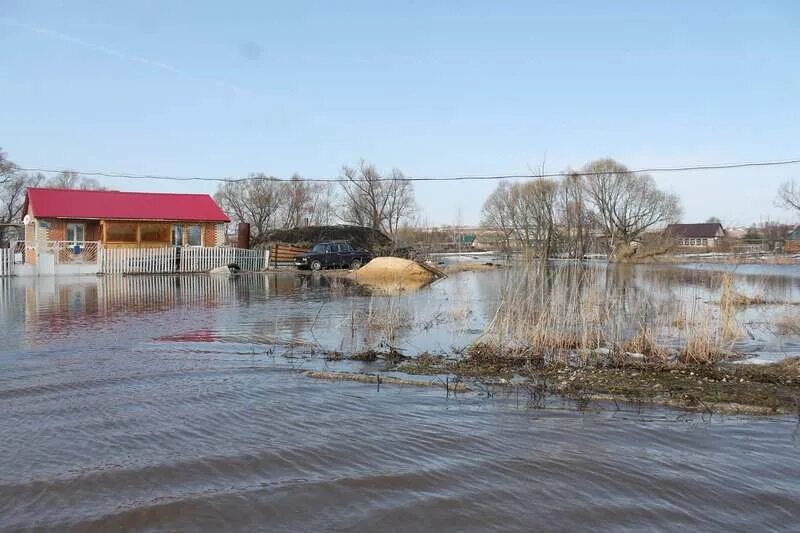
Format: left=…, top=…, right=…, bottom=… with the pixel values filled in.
left=99, top=247, right=266, bottom=274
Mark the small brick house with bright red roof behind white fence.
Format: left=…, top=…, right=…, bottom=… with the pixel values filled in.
left=23, top=188, right=230, bottom=252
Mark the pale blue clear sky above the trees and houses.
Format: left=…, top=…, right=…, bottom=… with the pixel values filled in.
left=0, top=0, right=800, bottom=225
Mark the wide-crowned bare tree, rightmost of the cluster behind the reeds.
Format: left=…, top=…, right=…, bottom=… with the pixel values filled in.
left=584, top=159, right=681, bottom=256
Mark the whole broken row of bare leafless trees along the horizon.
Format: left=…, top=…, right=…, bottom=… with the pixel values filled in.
left=0, top=144, right=800, bottom=248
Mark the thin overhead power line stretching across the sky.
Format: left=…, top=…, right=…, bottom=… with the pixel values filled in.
left=17, top=159, right=800, bottom=183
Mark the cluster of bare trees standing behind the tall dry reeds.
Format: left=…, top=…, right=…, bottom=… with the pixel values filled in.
left=482, top=159, right=681, bottom=257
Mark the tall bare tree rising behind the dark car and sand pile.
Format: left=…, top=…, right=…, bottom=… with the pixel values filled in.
left=339, top=160, right=415, bottom=234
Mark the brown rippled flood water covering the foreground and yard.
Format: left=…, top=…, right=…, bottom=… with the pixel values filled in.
left=0, top=267, right=800, bottom=531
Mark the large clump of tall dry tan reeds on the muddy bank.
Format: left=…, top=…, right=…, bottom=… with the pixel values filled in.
left=470, top=264, right=742, bottom=366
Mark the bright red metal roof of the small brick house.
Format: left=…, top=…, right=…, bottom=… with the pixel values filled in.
left=27, top=188, right=230, bottom=222
